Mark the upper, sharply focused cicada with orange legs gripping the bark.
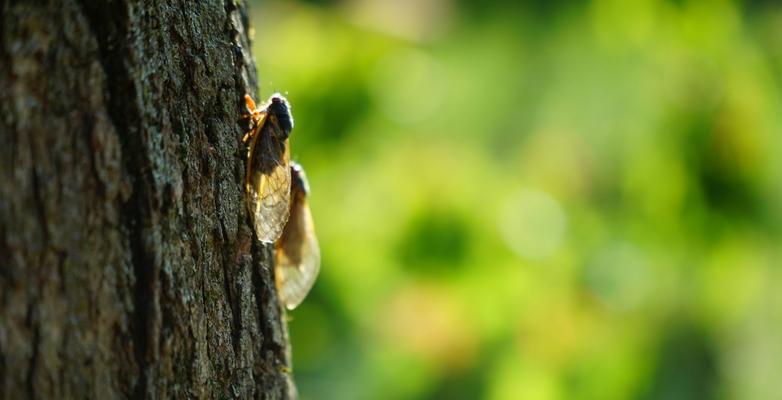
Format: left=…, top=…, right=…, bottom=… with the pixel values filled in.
left=242, top=94, right=293, bottom=243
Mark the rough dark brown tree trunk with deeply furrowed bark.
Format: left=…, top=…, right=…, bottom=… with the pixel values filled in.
left=0, top=0, right=294, bottom=399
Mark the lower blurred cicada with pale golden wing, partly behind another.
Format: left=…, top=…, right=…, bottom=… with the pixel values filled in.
left=275, top=162, right=320, bottom=310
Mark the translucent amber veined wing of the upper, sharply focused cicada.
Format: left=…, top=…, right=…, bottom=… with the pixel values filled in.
left=247, top=119, right=291, bottom=243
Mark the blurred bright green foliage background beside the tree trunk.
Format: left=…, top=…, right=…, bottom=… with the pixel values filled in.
left=251, top=0, right=782, bottom=399
